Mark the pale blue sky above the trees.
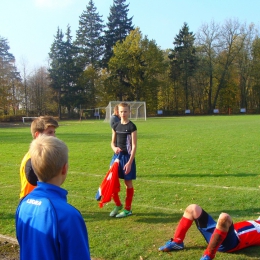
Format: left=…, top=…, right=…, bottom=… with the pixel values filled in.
left=0, top=0, right=260, bottom=71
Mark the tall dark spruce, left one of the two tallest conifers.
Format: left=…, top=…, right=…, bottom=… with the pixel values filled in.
left=75, top=0, right=105, bottom=69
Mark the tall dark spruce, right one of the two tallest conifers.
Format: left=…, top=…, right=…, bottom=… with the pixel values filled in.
left=103, top=0, right=134, bottom=67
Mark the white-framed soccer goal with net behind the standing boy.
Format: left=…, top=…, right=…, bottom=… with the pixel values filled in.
left=105, top=101, right=146, bottom=122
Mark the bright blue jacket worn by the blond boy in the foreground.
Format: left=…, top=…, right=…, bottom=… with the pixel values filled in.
left=16, top=182, right=90, bottom=260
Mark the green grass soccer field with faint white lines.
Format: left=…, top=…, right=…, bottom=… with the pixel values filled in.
left=0, top=115, right=260, bottom=260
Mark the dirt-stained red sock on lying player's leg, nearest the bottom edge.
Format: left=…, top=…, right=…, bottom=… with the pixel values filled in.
left=204, top=228, right=227, bottom=259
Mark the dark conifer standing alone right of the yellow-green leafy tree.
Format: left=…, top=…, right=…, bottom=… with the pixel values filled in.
left=169, top=23, right=197, bottom=109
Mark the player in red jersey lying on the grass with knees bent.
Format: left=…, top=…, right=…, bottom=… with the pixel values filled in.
left=159, top=204, right=260, bottom=260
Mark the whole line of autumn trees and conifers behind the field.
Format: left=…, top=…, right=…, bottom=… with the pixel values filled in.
left=0, top=0, right=260, bottom=117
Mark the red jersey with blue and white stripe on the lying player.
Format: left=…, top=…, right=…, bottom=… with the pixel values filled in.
left=228, top=220, right=260, bottom=252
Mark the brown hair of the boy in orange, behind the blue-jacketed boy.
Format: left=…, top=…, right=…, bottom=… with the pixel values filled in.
left=31, top=116, right=59, bottom=138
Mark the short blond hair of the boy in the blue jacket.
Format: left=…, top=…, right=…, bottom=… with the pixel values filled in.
left=29, top=135, right=68, bottom=182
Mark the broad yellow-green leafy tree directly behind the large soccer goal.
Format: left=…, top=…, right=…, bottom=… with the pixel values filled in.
left=107, top=28, right=163, bottom=112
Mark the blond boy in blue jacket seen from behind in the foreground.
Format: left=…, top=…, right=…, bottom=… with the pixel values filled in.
left=16, top=135, right=91, bottom=260
